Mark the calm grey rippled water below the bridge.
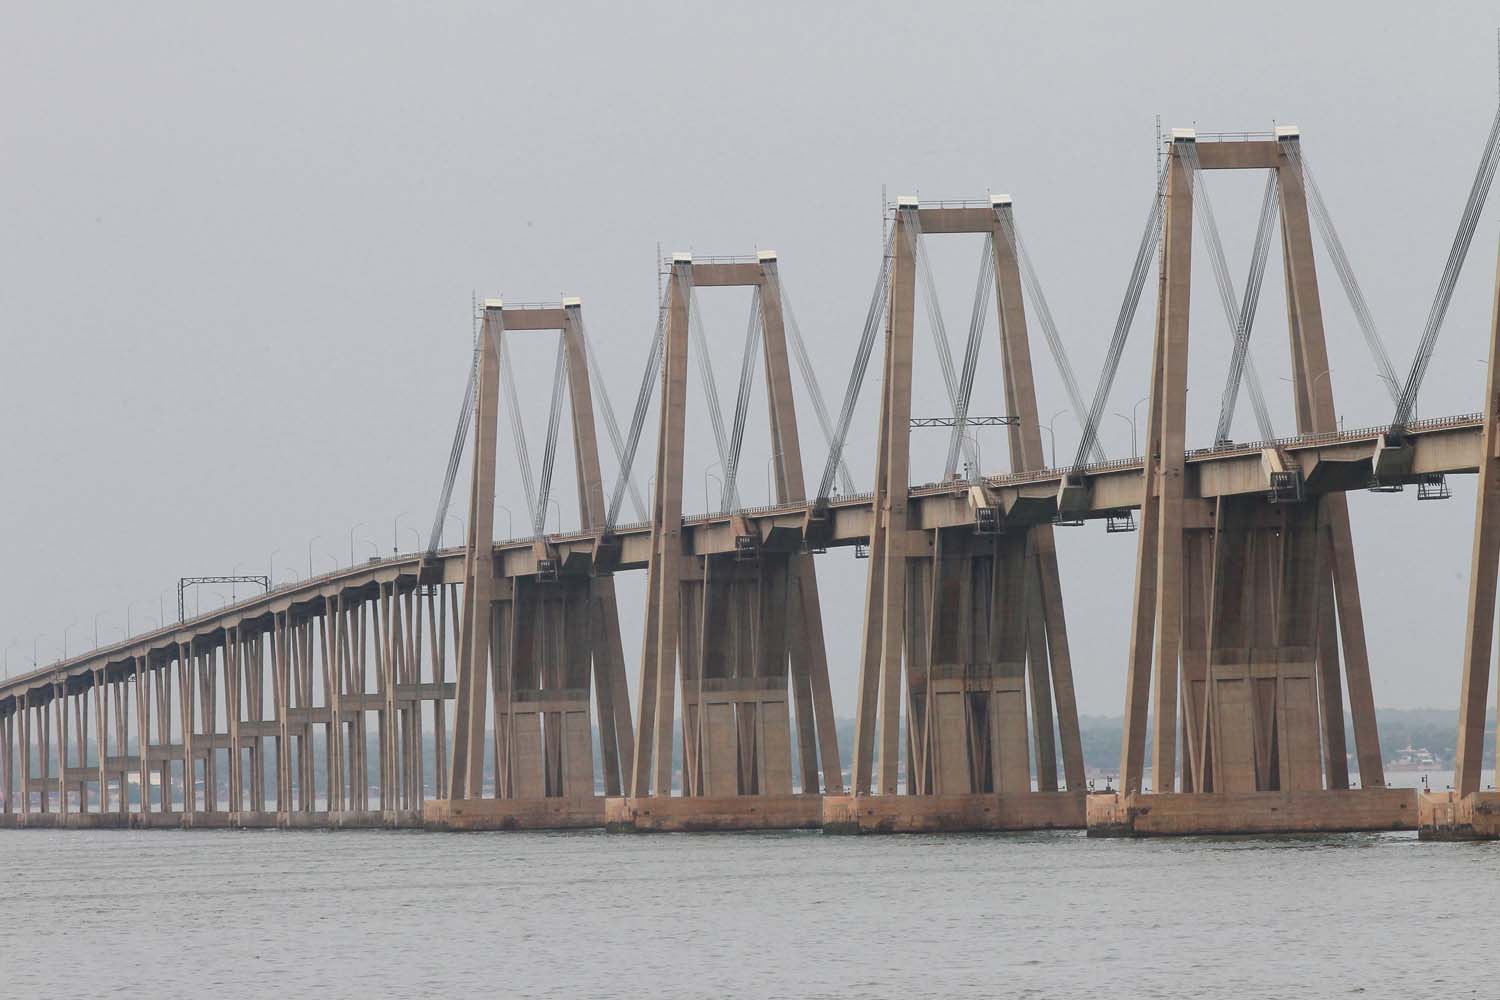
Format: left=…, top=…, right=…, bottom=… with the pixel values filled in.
left=0, top=815, right=1500, bottom=997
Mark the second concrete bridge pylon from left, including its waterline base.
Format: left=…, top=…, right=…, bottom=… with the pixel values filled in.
left=608, top=250, right=843, bottom=829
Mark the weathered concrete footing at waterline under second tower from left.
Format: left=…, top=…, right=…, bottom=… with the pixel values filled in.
left=605, top=795, right=824, bottom=834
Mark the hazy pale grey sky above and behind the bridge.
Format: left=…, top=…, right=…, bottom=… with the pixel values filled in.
left=0, top=1, right=1500, bottom=715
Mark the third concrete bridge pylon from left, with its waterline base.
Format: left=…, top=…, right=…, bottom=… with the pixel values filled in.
left=825, top=196, right=1085, bottom=832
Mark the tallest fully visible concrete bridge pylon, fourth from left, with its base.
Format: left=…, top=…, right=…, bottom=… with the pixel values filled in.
left=1089, top=127, right=1415, bottom=835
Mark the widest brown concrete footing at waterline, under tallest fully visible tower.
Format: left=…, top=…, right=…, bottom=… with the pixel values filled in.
left=1088, top=789, right=1418, bottom=837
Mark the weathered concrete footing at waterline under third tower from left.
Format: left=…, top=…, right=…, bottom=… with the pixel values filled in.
left=824, top=792, right=1085, bottom=834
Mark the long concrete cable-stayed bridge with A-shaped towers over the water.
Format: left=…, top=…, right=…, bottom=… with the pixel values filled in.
left=0, top=117, right=1500, bottom=837
